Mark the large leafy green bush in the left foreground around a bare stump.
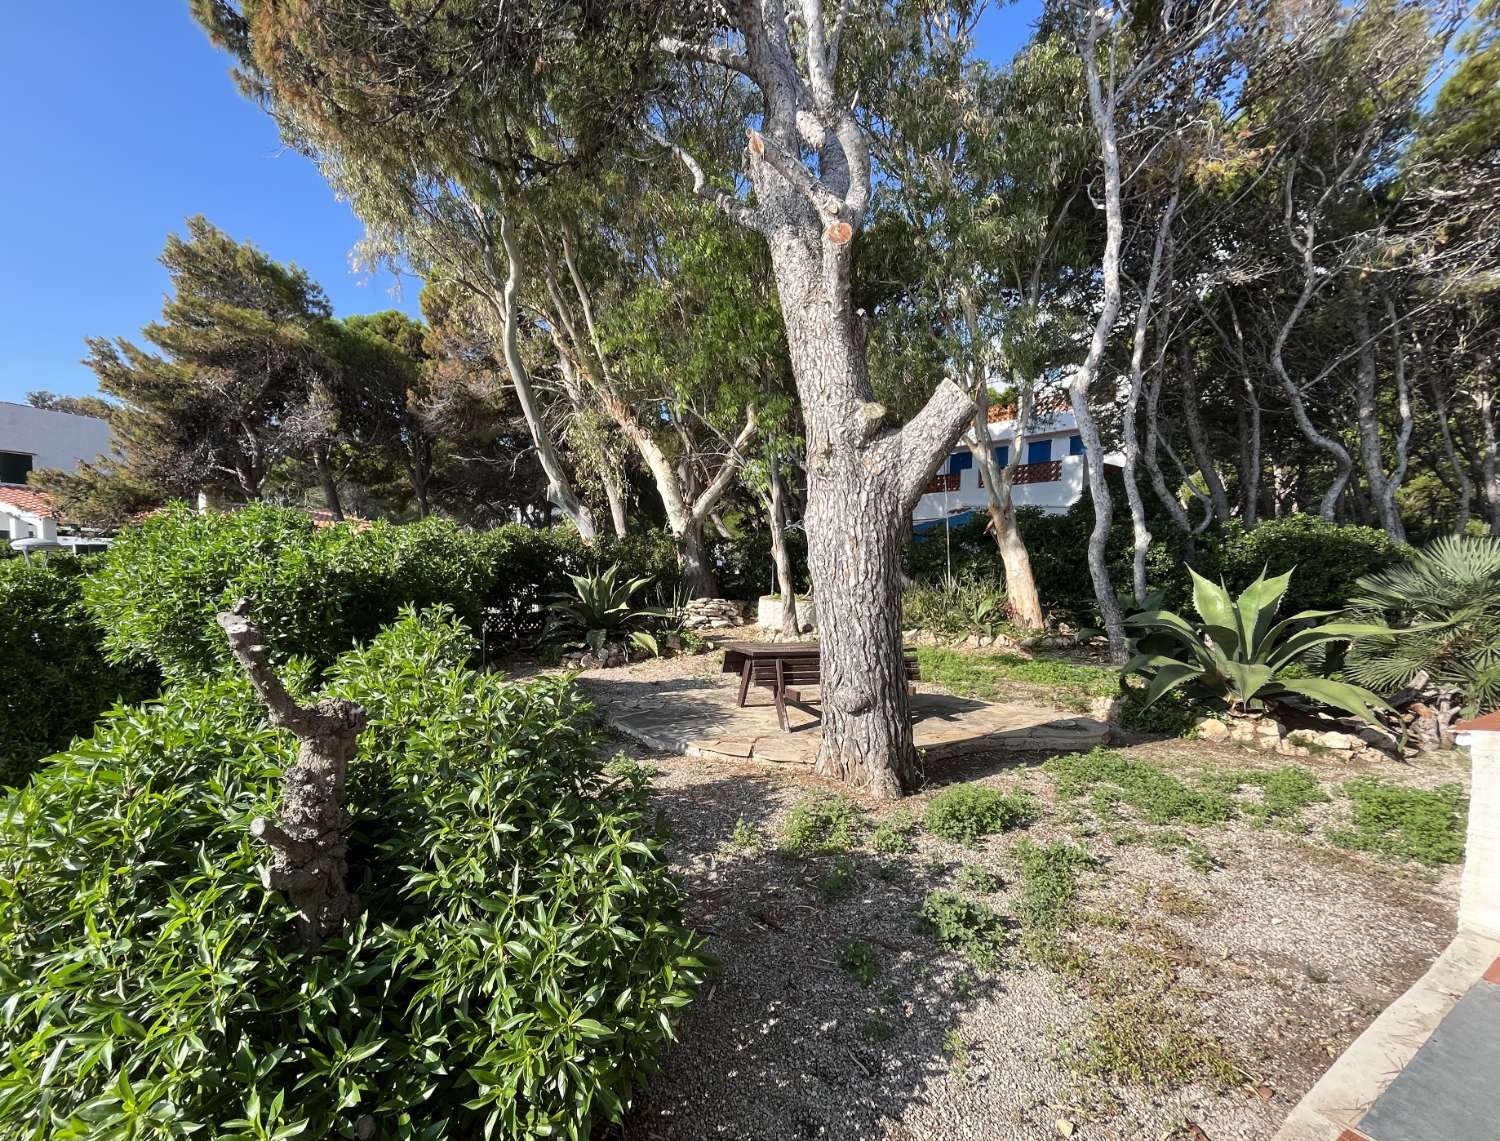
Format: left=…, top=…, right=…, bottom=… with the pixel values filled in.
left=0, top=615, right=701, bottom=1141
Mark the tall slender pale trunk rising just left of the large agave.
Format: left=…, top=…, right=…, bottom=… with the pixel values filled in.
left=1068, top=12, right=1128, bottom=661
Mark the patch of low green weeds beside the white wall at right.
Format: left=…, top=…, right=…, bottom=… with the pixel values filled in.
left=1329, top=778, right=1466, bottom=867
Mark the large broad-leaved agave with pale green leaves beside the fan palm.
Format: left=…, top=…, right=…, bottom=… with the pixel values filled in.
left=1125, top=567, right=1389, bottom=724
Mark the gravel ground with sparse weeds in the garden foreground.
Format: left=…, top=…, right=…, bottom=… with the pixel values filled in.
left=558, top=644, right=1467, bottom=1141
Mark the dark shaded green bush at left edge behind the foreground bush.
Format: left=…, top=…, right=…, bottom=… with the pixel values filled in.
left=0, top=555, right=156, bottom=786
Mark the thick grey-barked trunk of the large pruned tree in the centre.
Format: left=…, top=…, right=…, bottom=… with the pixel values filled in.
left=660, top=0, right=974, bottom=798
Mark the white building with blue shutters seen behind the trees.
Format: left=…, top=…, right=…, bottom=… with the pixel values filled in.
left=912, top=403, right=1119, bottom=531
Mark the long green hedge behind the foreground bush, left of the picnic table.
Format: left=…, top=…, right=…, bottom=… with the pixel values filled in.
left=84, top=504, right=677, bottom=678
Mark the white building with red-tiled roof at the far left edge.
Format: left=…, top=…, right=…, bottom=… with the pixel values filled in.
left=0, top=400, right=113, bottom=547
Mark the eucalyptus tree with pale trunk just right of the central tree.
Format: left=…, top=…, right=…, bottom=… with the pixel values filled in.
left=872, top=20, right=1089, bottom=628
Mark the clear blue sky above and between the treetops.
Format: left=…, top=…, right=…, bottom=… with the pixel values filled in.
left=0, top=0, right=1040, bottom=402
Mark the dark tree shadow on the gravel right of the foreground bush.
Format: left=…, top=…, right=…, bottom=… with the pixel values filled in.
left=605, top=757, right=1004, bottom=1141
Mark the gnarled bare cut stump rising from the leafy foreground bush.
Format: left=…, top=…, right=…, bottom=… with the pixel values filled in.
left=218, top=598, right=366, bottom=949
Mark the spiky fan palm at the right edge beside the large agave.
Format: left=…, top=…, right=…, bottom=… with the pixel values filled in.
left=1346, top=535, right=1500, bottom=717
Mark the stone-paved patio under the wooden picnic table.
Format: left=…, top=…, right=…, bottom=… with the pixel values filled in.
left=579, top=669, right=1110, bottom=766
